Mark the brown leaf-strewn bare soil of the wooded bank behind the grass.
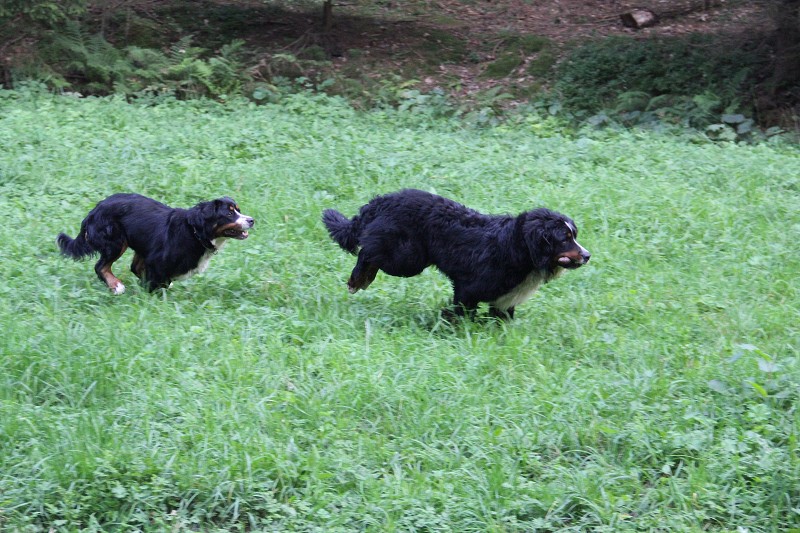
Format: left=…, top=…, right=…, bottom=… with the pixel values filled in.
left=0, top=0, right=773, bottom=106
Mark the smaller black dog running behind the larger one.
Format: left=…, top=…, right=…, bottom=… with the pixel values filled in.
left=56, top=193, right=255, bottom=294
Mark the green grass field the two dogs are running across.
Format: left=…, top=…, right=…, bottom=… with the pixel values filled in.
left=0, top=92, right=800, bottom=532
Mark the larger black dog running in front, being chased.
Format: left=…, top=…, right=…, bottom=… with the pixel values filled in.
left=322, top=189, right=591, bottom=318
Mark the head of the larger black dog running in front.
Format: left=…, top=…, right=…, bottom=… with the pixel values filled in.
left=521, top=208, right=592, bottom=272
